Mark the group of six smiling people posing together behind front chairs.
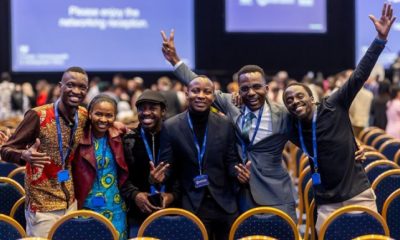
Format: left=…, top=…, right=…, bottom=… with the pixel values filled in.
left=1, top=4, right=395, bottom=240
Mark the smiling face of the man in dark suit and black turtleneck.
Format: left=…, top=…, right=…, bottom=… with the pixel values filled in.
left=186, top=76, right=214, bottom=112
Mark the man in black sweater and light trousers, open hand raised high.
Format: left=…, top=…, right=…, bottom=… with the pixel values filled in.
left=283, top=4, right=395, bottom=231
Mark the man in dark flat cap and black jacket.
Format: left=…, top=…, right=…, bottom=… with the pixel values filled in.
left=121, top=90, right=177, bottom=237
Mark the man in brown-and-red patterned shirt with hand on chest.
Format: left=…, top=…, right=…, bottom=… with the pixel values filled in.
left=1, top=67, right=88, bottom=238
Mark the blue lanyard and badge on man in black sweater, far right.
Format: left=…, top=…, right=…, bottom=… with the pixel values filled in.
left=298, top=108, right=321, bottom=186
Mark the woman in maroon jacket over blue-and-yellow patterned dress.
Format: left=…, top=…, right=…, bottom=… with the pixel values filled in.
left=72, top=94, right=128, bottom=240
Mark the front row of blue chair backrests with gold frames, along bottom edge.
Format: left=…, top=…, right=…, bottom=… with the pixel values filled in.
left=0, top=204, right=396, bottom=240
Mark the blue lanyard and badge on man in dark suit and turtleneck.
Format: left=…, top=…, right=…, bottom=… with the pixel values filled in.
left=187, top=112, right=209, bottom=188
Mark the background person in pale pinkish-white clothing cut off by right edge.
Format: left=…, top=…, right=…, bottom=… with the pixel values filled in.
left=386, top=87, right=400, bottom=139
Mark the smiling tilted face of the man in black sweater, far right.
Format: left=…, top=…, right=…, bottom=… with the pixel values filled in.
left=283, top=85, right=315, bottom=121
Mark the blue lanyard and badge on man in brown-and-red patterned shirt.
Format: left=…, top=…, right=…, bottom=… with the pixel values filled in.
left=54, top=100, right=79, bottom=183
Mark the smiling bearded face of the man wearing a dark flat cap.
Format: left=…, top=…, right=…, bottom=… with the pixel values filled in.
left=137, top=102, right=165, bottom=132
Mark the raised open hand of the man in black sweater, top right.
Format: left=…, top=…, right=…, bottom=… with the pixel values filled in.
left=369, top=3, right=396, bottom=40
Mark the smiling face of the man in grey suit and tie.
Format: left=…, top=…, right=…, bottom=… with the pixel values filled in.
left=239, top=72, right=268, bottom=111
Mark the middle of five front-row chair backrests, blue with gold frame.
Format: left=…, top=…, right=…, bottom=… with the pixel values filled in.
left=138, top=208, right=208, bottom=240
